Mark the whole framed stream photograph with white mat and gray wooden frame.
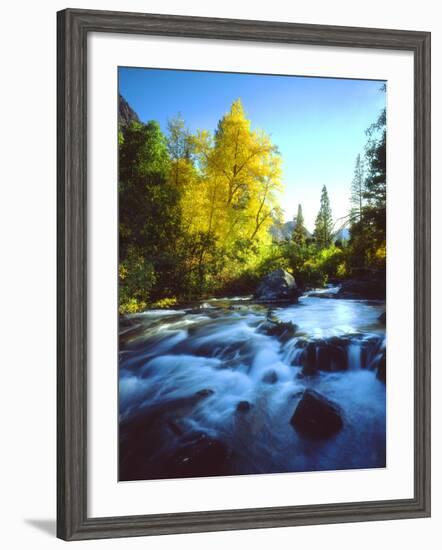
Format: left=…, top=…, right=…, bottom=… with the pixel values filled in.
left=57, top=9, right=430, bottom=540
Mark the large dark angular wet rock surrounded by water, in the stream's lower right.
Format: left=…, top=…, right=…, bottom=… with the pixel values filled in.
left=290, top=389, right=343, bottom=438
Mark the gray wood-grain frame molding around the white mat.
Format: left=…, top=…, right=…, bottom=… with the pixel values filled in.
left=57, top=9, right=430, bottom=540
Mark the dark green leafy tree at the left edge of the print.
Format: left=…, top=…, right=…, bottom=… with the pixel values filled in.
left=119, top=121, right=180, bottom=310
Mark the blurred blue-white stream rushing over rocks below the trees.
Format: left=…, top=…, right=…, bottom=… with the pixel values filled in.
left=119, top=287, right=386, bottom=481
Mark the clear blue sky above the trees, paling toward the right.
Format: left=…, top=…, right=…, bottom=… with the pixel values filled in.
left=119, top=68, right=385, bottom=230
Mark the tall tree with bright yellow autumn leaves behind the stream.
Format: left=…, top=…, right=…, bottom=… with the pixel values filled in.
left=182, top=100, right=281, bottom=296
